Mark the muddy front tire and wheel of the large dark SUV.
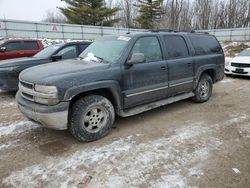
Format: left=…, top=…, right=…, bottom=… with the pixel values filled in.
left=69, top=95, right=115, bottom=142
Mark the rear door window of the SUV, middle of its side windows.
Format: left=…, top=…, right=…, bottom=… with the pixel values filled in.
left=164, top=35, right=189, bottom=59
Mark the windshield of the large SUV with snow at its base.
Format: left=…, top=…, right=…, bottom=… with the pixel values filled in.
left=80, top=37, right=130, bottom=63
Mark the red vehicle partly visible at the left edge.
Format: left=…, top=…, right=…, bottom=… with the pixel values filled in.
left=0, top=39, right=44, bottom=60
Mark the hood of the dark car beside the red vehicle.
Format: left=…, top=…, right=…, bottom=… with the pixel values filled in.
left=0, top=57, right=46, bottom=68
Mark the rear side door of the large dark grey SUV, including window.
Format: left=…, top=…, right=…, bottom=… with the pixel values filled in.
left=164, top=35, right=194, bottom=96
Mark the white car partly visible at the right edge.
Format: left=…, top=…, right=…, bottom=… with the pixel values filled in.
left=225, top=48, right=250, bottom=76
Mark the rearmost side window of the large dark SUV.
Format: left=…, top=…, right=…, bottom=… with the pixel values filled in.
left=189, top=34, right=222, bottom=55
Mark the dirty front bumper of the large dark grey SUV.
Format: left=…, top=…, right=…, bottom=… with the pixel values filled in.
left=16, top=92, right=69, bottom=130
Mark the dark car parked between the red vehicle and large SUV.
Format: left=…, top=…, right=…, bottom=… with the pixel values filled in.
left=0, top=42, right=91, bottom=91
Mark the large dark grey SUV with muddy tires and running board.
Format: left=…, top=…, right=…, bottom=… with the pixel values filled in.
left=16, top=32, right=225, bottom=141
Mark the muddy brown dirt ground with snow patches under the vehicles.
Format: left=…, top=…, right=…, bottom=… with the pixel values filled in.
left=0, top=77, right=250, bottom=188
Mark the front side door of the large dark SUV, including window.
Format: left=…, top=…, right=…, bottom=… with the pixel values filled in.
left=122, top=36, right=168, bottom=108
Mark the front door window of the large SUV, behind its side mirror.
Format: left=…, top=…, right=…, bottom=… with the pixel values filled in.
left=132, top=37, right=162, bottom=62
